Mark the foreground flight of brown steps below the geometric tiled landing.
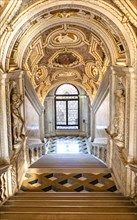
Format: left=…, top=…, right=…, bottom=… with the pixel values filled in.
left=0, top=192, right=137, bottom=220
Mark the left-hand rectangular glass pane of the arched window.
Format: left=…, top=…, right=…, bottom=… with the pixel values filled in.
left=56, top=101, right=66, bottom=125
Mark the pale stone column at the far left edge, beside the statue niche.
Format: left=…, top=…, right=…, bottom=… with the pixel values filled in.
left=0, top=73, right=10, bottom=164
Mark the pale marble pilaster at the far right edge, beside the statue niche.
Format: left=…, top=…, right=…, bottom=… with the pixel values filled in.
left=123, top=67, right=137, bottom=161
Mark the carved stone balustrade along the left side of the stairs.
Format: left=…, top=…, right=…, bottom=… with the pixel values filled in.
left=0, top=141, right=27, bottom=205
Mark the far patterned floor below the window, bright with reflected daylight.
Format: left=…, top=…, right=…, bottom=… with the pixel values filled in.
left=46, top=136, right=88, bottom=154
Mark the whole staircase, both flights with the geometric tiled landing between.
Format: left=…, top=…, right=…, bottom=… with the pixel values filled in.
left=0, top=152, right=137, bottom=220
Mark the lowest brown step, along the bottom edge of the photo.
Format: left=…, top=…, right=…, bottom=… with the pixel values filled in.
left=0, top=212, right=137, bottom=220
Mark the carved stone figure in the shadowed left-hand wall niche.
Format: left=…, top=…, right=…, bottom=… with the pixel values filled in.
left=11, top=84, right=24, bottom=144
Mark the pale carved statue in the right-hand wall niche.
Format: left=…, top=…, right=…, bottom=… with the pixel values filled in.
left=114, top=89, right=125, bottom=142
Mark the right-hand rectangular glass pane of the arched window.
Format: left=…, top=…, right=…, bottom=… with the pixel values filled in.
left=68, top=100, right=78, bottom=125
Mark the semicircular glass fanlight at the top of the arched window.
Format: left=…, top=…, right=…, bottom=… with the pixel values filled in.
left=56, top=84, right=78, bottom=95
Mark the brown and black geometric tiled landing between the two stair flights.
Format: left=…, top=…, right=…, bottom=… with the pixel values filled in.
left=21, top=173, right=117, bottom=192
